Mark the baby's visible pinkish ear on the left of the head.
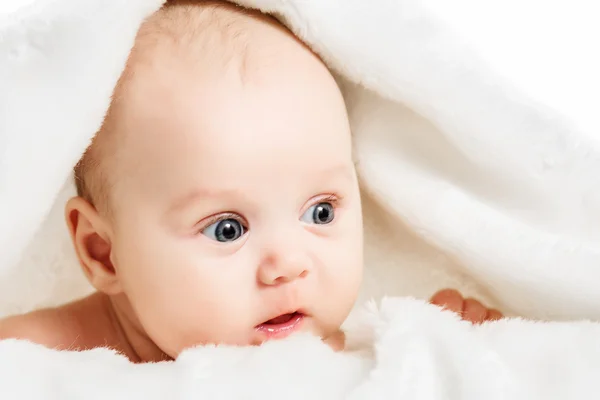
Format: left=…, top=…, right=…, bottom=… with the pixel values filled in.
left=65, top=197, right=121, bottom=295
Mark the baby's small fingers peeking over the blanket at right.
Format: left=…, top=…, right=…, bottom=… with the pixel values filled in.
left=429, top=289, right=503, bottom=324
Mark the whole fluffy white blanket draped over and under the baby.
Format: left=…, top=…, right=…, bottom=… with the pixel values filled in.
left=0, top=0, right=600, bottom=399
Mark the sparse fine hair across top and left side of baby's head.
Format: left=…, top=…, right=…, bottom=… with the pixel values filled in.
left=74, top=0, right=294, bottom=213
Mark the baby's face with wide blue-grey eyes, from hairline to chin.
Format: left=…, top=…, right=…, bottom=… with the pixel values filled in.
left=104, top=37, right=363, bottom=356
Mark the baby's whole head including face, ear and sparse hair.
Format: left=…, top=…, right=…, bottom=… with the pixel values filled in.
left=66, top=2, right=363, bottom=357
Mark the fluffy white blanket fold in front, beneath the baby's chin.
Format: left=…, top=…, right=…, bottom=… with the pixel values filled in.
left=0, top=299, right=600, bottom=400
